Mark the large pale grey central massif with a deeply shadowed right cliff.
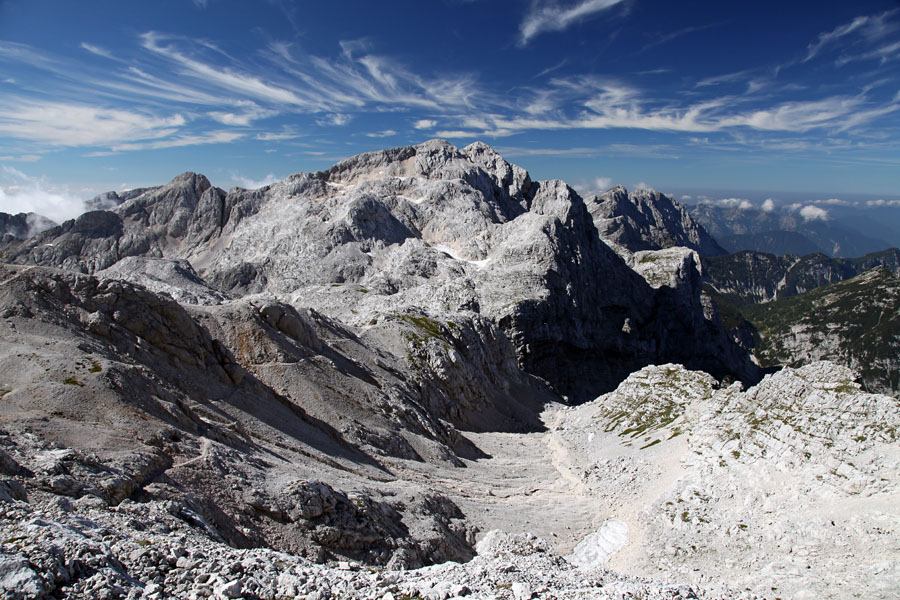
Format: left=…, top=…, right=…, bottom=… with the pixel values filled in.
left=15, top=140, right=758, bottom=399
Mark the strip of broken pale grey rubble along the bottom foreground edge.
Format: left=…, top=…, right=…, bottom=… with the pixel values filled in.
left=0, top=501, right=724, bottom=600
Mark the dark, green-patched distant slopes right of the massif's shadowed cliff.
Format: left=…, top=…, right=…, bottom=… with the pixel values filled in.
left=703, top=248, right=900, bottom=393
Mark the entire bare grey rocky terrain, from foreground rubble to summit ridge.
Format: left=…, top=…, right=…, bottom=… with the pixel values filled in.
left=0, top=140, right=900, bottom=600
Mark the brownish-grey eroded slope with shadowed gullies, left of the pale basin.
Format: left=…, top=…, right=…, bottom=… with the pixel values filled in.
left=0, top=266, right=512, bottom=567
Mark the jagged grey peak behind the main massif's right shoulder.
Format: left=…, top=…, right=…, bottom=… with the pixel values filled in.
left=586, top=185, right=726, bottom=256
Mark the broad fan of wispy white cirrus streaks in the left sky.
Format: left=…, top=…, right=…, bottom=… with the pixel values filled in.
left=0, top=32, right=481, bottom=156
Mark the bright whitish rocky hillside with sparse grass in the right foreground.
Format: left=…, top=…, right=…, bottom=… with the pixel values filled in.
left=557, top=362, right=900, bottom=598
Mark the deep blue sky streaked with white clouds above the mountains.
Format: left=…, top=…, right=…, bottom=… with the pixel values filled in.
left=0, top=0, right=900, bottom=219
